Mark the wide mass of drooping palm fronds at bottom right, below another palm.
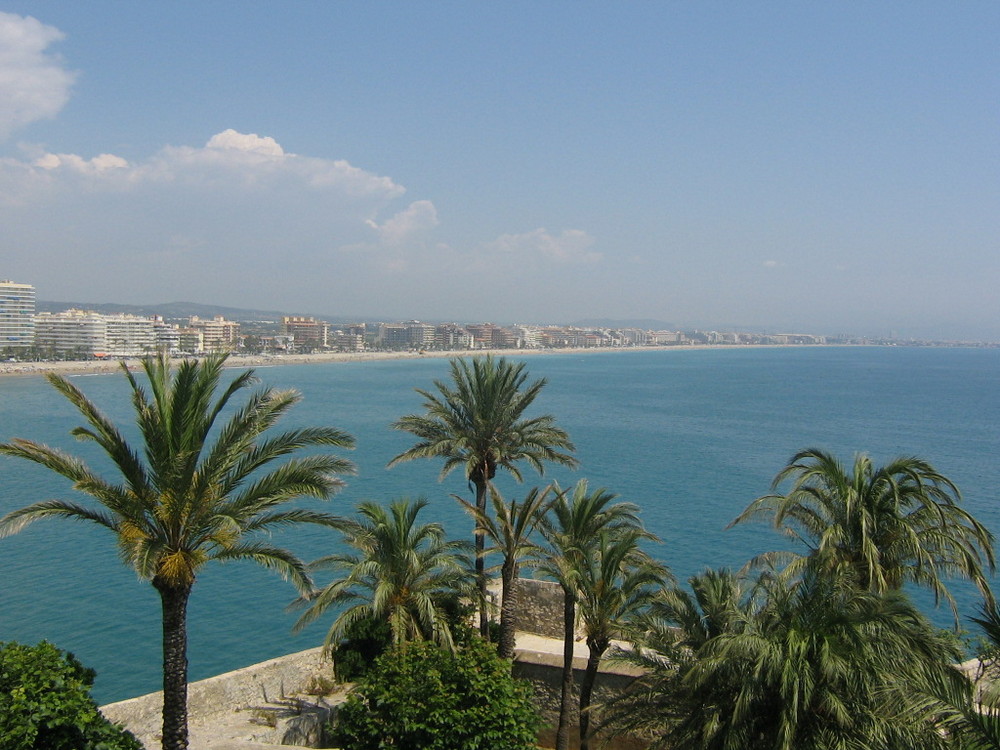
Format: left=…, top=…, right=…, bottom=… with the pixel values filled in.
left=609, top=573, right=968, bottom=750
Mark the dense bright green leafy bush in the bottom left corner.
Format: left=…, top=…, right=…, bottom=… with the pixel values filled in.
left=0, top=641, right=142, bottom=750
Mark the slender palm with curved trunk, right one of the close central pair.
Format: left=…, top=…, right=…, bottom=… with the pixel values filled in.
left=577, top=528, right=669, bottom=750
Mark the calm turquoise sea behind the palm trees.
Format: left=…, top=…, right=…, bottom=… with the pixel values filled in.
left=0, top=347, right=1000, bottom=702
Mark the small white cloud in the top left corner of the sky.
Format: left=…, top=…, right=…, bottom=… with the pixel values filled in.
left=0, top=12, right=76, bottom=138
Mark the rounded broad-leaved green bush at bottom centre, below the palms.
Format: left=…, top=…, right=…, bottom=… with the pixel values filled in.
left=336, top=639, right=538, bottom=750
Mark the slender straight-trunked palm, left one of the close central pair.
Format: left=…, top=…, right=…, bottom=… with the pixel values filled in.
left=536, top=479, right=642, bottom=750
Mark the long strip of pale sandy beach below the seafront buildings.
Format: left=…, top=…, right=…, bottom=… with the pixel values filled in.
left=0, top=344, right=772, bottom=378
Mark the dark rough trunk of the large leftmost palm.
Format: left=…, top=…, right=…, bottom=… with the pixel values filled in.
left=153, top=577, right=191, bottom=750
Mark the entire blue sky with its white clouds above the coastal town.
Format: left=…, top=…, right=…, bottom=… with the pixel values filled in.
left=0, top=1, right=1000, bottom=340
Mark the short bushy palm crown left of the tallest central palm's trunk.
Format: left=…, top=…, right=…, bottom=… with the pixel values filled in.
left=295, top=500, right=469, bottom=648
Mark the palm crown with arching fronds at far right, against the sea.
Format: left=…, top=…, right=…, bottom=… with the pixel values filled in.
left=730, top=448, right=995, bottom=618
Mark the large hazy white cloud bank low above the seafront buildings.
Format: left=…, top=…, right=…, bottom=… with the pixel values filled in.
left=0, top=130, right=601, bottom=315
